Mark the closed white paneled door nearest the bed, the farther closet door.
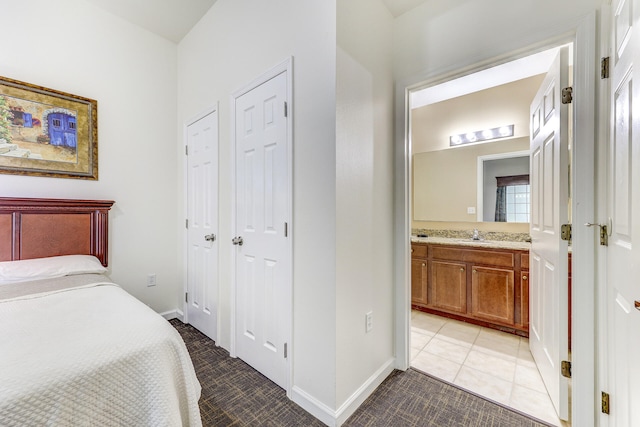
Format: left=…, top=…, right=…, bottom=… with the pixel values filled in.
left=186, top=111, right=218, bottom=341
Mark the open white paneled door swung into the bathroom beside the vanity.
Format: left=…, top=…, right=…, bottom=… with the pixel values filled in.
left=529, top=47, right=569, bottom=420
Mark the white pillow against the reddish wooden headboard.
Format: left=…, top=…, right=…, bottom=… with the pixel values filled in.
left=0, top=255, right=107, bottom=285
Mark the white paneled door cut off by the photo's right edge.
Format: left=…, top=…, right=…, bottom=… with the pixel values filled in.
left=604, top=0, right=640, bottom=426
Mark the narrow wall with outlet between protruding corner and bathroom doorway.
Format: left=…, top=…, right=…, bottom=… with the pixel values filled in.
left=336, top=0, right=394, bottom=416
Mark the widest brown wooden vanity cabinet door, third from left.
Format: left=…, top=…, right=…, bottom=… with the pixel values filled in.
left=470, top=266, right=514, bottom=325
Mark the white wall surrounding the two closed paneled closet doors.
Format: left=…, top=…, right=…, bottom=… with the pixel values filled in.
left=178, top=0, right=336, bottom=411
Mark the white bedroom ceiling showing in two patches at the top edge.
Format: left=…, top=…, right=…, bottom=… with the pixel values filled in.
left=85, top=0, right=428, bottom=43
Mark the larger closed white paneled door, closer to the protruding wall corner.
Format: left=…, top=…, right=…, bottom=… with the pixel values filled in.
left=233, top=72, right=291, bottom=389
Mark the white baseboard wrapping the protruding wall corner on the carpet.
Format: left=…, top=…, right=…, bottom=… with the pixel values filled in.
left=291, top=358, right=395, bottom=427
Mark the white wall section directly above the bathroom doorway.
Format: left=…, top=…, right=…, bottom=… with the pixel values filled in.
left=393, top=0, right=601, bottom=83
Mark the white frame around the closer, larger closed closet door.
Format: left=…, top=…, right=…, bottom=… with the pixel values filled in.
left=229, top=56, right=295, bottom=398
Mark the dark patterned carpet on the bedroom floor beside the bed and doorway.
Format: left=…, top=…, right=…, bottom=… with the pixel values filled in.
left=171, top=319, right=547, bottom=427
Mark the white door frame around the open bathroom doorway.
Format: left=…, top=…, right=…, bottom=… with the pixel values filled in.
left=394, top=12, right=600, bottom=425
